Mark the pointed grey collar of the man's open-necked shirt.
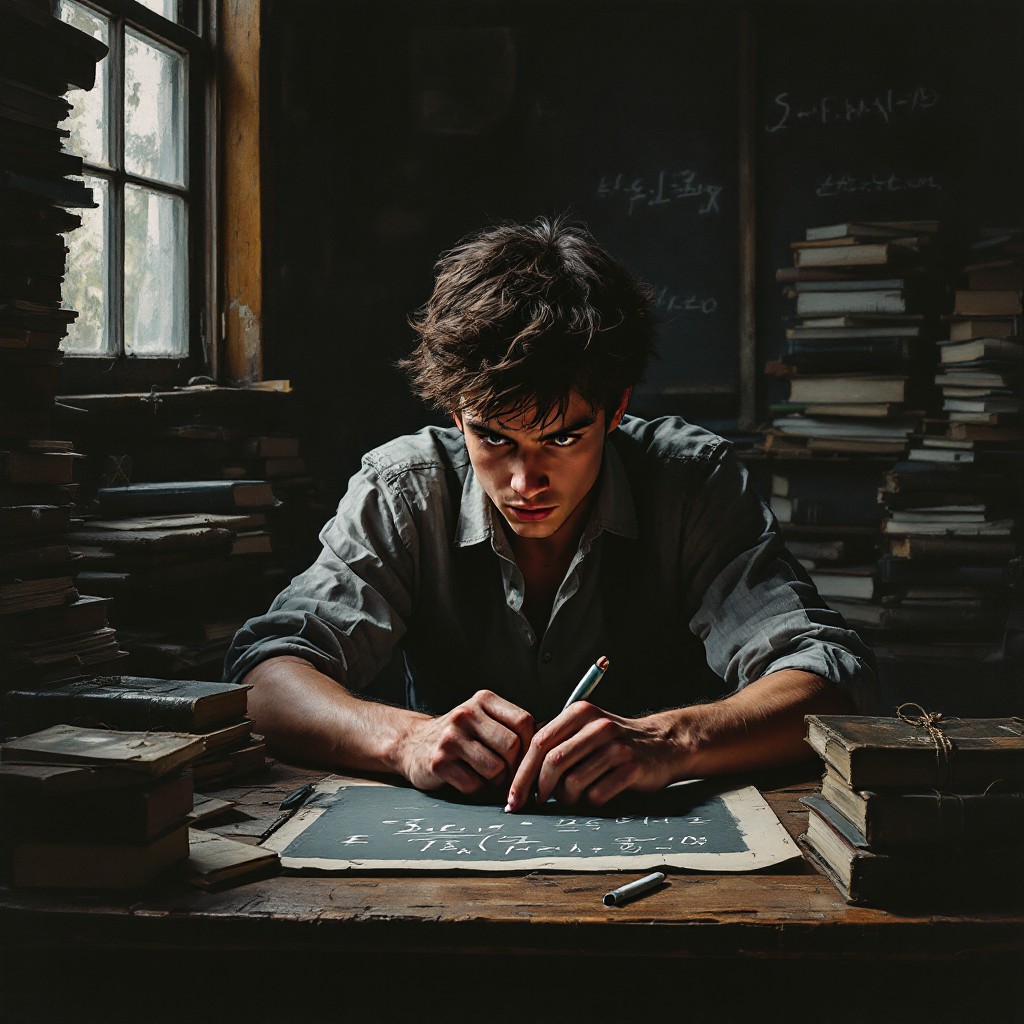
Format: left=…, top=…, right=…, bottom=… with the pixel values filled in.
left=455, top=438, right=639, bottom=548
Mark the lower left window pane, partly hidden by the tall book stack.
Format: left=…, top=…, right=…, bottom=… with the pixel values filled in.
left=60, top=176, right=110, bottom=355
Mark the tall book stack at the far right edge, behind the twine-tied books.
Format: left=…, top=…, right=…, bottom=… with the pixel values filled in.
left=876, top=231, right=1024, bottom=715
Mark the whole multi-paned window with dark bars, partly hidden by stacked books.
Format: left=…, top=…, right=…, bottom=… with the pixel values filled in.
left=58, top=0, right=208, bottom=369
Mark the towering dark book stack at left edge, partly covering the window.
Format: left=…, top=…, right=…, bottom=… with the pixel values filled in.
left=0, top=2, right=123, bottom=686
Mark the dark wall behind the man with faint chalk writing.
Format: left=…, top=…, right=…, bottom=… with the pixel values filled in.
left=262, top=0, right=1024, bottom=492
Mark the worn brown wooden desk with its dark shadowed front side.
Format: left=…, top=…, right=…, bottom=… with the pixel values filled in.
left=0, top=764, right=1024, bottom=1024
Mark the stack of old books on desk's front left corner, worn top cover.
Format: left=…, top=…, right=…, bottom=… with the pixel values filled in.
left=0, top=725, right=205, bottom=889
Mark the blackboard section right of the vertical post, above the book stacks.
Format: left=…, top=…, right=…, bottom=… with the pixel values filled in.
left=754, top=0, right=1024, bottom=412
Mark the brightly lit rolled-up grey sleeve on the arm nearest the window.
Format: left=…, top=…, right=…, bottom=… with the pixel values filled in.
left=224, top=462, right=418, bottom=690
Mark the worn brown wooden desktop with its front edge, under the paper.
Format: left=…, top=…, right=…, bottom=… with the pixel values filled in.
left=0, top=763, right=1024, bottom=959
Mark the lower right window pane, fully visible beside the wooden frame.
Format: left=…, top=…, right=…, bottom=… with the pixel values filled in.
left=125, top=184, right=188, bottom=355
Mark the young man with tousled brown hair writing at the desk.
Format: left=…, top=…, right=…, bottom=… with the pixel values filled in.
left=225, top=219, right=874, bottom=810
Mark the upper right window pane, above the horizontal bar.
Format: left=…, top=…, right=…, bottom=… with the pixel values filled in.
left=125, top=29, right=185, bottom=184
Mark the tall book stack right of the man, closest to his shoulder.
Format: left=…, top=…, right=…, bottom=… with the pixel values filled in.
left=765, top=221, right=937, bottom=622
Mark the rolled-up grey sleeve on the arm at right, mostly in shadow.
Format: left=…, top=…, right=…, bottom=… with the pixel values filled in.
left=681, top=450, right=878, bottom=713
